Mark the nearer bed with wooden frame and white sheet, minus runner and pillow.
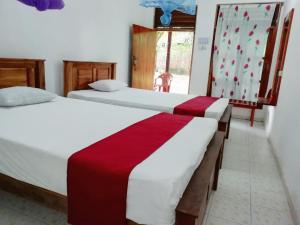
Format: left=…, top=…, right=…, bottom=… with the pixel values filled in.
left=0, top=59, right=224, bottom=225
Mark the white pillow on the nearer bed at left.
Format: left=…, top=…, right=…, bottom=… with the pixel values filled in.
left=0, top=87, right=57, bottom=107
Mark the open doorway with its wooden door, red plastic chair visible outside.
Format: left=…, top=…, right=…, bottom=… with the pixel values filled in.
left=131, top=9, right=196, bottom=94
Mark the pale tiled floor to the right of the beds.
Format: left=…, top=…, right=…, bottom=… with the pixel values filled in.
left=203, top=120, right=293, bottom=225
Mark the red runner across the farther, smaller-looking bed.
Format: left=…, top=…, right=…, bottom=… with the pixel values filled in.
left=174, top=96, right=219, bottom=117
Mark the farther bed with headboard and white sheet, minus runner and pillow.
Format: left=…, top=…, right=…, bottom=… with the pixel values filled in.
left=64, top=61, right=232, bottom=138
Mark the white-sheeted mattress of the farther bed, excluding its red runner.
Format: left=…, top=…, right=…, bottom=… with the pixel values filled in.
left=68, top=88, right=229, bottom=121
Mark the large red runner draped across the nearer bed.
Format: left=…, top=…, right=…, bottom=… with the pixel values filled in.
left=67, top=113, right=192, bottom=225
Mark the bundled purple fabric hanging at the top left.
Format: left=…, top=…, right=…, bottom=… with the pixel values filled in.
left=18, top=0, right=65, bottom=11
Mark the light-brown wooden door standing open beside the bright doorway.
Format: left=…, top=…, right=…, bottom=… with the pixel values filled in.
left=131, top=25, right=157, bottom=90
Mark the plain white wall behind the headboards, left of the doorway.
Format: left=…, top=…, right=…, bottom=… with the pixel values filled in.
left=0, top=0, right=154, bottom=94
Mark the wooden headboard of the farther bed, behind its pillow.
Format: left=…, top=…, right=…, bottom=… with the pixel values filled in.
left=64, top=60, right=117, bottom=96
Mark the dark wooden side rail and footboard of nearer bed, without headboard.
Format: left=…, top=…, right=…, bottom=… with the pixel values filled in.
left=0, top=132, right=225, bottom=225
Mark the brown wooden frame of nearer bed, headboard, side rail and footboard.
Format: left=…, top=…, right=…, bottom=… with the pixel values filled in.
left=0, top=59, right=225, bottom=225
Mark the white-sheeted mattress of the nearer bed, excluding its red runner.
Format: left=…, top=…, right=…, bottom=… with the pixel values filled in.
left=0, top=97, right=217, bottom=225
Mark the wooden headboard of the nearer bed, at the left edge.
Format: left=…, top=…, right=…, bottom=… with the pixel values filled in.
left=0, top=58, right=45, bottom=89
